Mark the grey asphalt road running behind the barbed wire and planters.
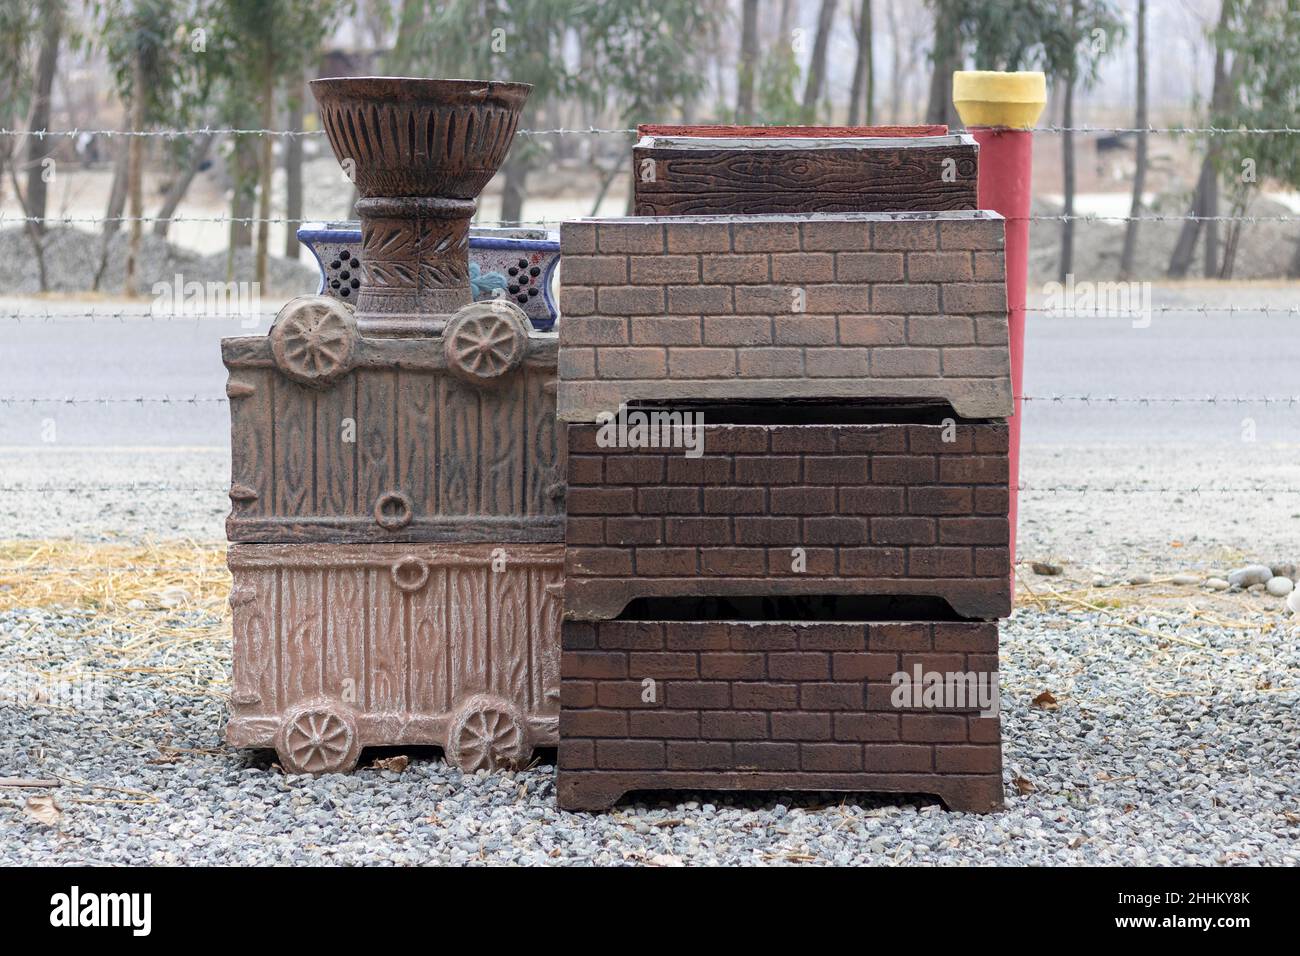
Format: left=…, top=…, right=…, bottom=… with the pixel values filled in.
left=0, top=285, right=1300, bottom=447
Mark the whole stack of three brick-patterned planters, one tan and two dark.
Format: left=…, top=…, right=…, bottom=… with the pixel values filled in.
left=559, top=211, right=1011, bottom=810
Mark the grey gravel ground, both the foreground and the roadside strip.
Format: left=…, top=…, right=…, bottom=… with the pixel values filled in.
left=0, top=445, right=1300, bottom=865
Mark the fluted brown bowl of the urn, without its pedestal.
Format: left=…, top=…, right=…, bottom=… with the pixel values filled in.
left=312, top=77, right=533, bottom=199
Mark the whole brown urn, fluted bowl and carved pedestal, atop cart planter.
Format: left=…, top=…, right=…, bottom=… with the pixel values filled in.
left=311, top=77, right=532, bottom=336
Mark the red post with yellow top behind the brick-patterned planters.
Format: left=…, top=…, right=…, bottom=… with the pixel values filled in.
left=953, top=70, right=1047, bottom=593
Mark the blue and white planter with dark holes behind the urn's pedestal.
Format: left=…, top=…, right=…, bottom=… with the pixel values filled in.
left=298, top=222, right=560, bottom=332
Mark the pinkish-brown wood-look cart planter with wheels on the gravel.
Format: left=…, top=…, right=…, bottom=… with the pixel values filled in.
left=226, top=544, right=563, bottom=773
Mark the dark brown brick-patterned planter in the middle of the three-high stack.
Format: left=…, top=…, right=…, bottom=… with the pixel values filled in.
left=564, top=410, right=1011, bottom=619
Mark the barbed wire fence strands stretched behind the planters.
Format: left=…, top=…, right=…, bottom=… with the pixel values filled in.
left=0, top=125, right=1300, bottom=502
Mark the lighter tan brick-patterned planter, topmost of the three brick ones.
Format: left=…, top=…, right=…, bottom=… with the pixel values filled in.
left=559, top=211, right=1011, bottom=421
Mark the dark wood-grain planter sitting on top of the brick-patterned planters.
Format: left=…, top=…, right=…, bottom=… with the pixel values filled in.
left=632, top=127, right=979, bottom=216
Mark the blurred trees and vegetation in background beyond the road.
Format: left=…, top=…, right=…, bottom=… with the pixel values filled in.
left=0, top=0, right=1300, bottom=291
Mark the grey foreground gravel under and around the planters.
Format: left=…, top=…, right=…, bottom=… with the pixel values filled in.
left=0, top=607, right=1300, bottom=865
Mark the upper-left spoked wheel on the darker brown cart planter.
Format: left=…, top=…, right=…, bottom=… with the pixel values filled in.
left=270, top=295, right=358, bottom=389
